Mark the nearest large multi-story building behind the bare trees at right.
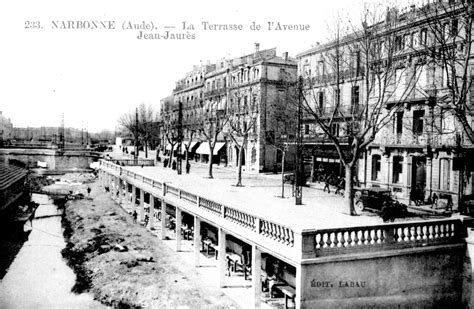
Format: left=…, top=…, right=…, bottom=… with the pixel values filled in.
left=297, top=1, right=473, bottom=205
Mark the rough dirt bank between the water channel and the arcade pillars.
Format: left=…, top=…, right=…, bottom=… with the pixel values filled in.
left=63, top=177, right=238, bottom=308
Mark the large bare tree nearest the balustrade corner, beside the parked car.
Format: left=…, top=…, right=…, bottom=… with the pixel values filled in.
left=299, top=10, right=416, bottom=215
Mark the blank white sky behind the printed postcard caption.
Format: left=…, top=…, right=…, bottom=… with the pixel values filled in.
left=0, top=0, right=409, bottom=132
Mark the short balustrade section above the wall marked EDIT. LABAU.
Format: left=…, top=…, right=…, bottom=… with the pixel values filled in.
left=312, top=220, right=463, bottom=257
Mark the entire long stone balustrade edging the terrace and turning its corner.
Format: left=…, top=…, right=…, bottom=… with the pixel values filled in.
left=101, top=161, right=465, bottom=259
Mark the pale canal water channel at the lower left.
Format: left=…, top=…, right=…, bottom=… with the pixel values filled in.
left=0, top=194, right=105, bottom=309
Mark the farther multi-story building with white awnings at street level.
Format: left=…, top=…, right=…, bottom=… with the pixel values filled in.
left=161, top=44, right=297, bottom=172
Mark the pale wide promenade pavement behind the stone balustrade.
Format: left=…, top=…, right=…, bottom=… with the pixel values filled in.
left=107, top=148, right=396, bottom=230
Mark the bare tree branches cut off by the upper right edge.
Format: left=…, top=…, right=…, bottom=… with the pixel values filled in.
left=415, top=0, right=474, bottom=143
